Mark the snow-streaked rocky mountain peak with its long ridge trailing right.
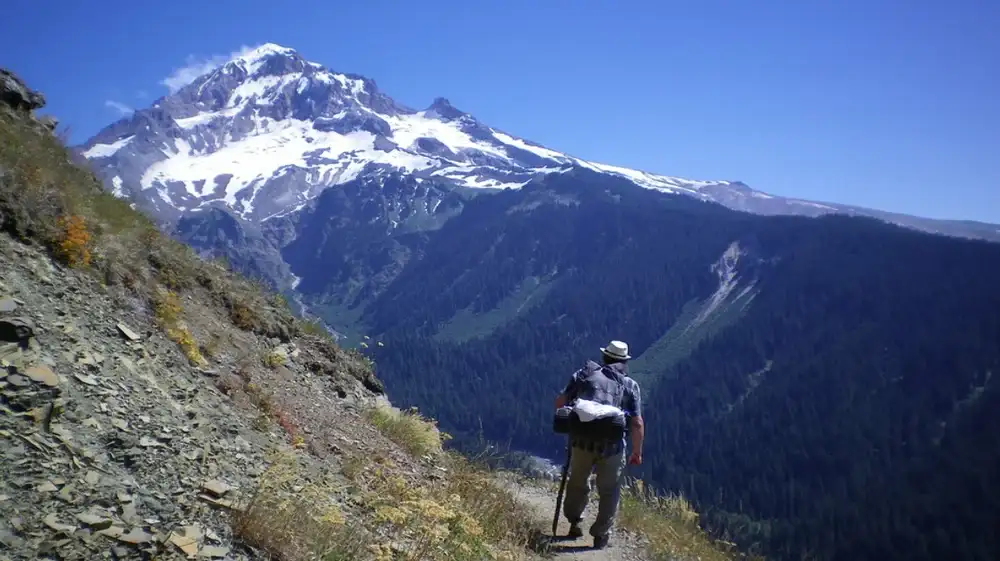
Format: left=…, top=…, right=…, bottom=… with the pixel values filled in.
left=79, top=44, right=1000, bottom=243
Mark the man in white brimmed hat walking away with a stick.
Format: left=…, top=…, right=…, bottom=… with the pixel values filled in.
left=555, top=341, right=644, bottom=549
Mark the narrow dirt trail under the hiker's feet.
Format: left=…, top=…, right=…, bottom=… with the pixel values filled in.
left=504, top=478, right=648, bottom=561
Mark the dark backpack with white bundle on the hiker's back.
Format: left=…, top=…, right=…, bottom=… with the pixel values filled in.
left=552, top=361, right=628, bottom=441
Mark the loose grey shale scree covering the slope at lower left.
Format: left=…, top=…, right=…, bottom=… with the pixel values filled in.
left=0, top=236, right=282, bottom=559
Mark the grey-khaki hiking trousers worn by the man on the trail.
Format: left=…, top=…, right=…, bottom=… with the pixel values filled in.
left=563, top=446, right=625, bottom=537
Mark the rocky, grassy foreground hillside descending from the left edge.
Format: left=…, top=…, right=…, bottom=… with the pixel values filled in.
left=0, top=69, right=752, bottom=561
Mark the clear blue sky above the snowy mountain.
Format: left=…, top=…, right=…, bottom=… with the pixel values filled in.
left=0, top=0, right=1000, bottom=222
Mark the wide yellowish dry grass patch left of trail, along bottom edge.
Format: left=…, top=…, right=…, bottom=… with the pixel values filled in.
left=232, top=438, right=533, bottom=561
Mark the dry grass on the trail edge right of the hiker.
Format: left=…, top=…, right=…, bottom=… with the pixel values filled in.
left=618, top=479, right=756, bottom=561
